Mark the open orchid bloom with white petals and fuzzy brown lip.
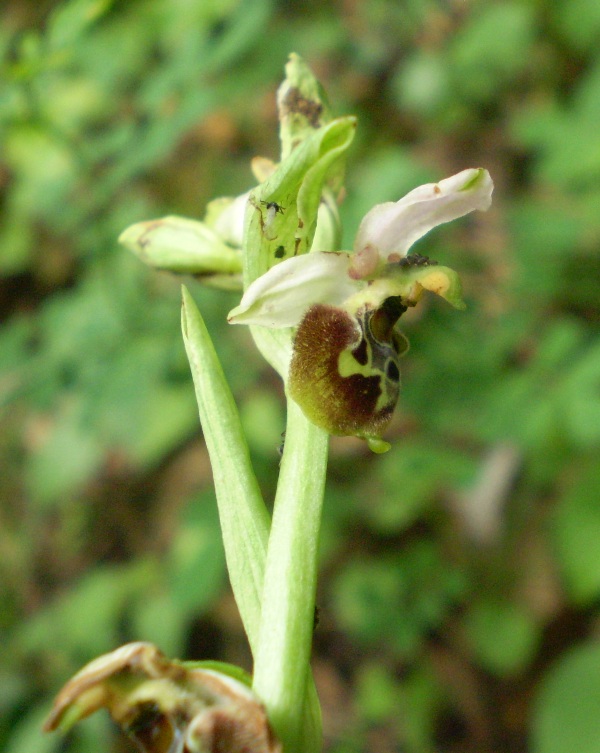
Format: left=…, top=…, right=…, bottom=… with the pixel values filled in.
left=229, top=168, right=493, bottom=449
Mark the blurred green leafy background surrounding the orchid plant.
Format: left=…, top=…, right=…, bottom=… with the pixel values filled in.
left=0, top=0, right=600, bottom=753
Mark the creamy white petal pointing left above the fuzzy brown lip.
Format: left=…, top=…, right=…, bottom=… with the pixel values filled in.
left=228, top=251, right=364, bottom=329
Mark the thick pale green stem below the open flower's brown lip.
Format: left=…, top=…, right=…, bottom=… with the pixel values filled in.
left=253, top=400, right=328, bottom=753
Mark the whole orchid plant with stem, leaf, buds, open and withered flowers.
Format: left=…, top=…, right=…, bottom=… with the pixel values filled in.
left=45, top=54, right=493, bottom=753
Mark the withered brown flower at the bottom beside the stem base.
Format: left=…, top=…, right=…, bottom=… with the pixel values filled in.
left=44, top=643, right=281, bottom=753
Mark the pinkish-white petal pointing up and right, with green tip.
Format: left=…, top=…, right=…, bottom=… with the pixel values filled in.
left=354, top=167, right=494, bottom=259
